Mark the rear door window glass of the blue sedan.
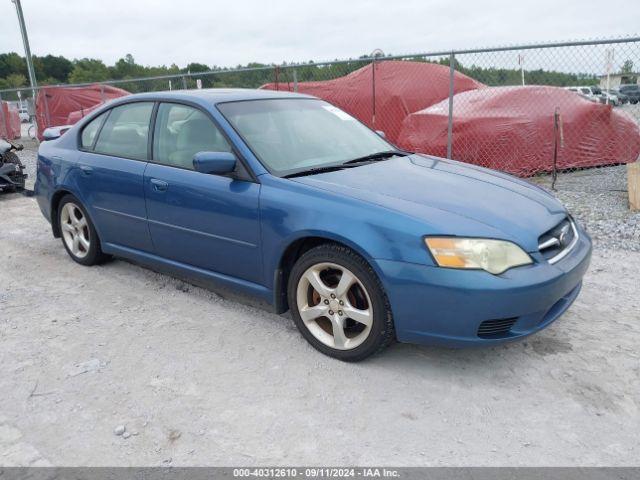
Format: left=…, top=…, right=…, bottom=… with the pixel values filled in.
left=94, top=102, right=153, bottom=160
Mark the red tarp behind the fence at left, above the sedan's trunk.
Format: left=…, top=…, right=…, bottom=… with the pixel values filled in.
left=36, top=85, right=129, bottom=140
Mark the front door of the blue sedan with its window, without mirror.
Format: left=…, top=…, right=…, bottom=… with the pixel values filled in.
left=144, top=103, right=262, bottom=283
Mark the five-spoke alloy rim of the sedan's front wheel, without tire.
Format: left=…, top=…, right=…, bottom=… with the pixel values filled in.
left=296, top=263, right=373, bottom=350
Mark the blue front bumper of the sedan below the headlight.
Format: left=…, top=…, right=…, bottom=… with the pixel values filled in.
left=377, top=227, right=591, bottom=347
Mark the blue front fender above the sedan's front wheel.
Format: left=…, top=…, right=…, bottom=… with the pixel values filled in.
left=260, top=175, right=433, bottom=288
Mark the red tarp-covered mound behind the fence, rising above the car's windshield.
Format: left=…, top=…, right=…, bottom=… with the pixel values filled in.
left=260, top=60, right=483, bottom=142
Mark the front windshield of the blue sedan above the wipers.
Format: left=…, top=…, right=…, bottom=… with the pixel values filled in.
left=218, top=98, right=395, bottom=176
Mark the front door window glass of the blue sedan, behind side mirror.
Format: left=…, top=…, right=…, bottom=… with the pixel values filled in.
left=153, top=103, right=231, bottom=169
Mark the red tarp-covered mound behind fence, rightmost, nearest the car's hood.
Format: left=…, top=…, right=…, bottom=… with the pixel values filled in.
left=398, top=86, right=640, bottom=176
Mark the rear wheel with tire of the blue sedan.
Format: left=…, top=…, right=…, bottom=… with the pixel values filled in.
left=57, top=195, right=108, bottom=267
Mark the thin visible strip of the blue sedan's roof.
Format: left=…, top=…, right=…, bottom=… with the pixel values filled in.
left=117, top=88, right=315, bottom=104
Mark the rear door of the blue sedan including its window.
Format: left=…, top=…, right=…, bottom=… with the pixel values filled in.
left=76, top=102, right=154, bottom=252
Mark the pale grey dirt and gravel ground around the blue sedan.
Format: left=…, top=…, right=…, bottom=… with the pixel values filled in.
left=0, top=195, right=640, bottom=466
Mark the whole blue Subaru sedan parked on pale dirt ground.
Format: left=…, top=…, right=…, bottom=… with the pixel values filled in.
left=36, top=90, right=591, bottom=361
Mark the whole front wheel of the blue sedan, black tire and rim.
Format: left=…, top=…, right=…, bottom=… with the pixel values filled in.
left=287, top=244, right=395, bottom=362
